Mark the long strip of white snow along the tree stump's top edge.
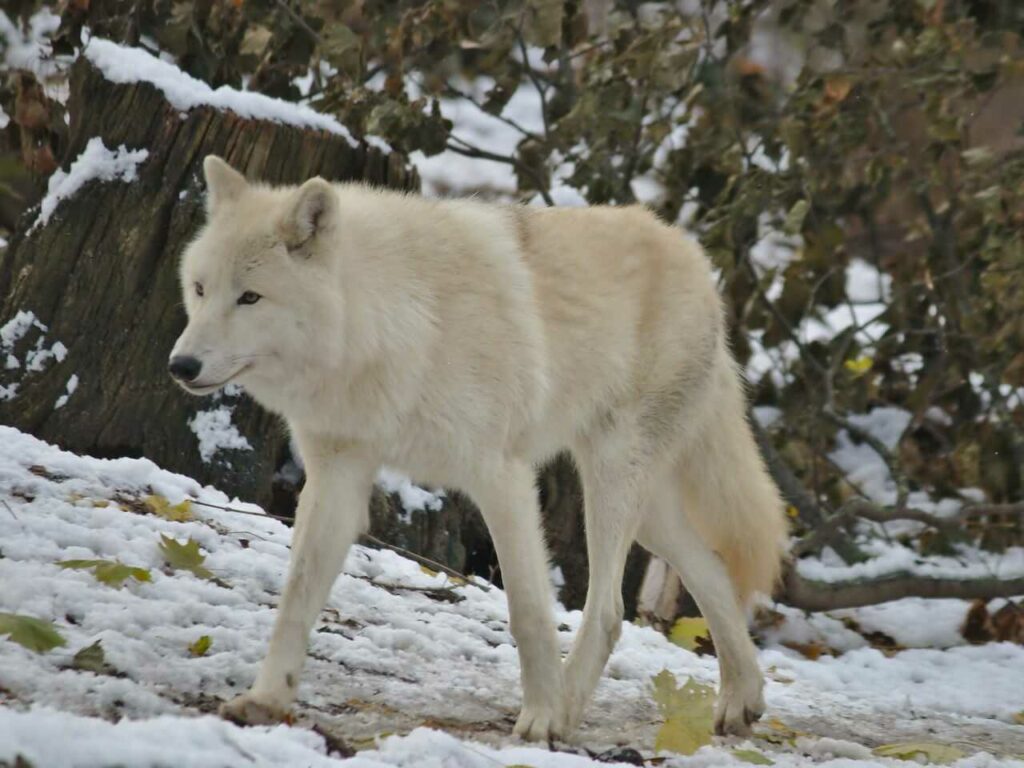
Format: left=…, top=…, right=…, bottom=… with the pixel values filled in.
left=83, top=38, right=355, bottom=146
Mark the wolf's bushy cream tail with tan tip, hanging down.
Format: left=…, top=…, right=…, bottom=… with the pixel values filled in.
left=679, top=345, right=788, bottom=605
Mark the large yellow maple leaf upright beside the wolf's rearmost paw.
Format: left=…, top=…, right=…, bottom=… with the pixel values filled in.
left=651, top=670, right=715, bottom=755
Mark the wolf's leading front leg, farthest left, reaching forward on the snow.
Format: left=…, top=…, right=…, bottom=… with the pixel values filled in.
left=220, top=445, right=375, bottom=725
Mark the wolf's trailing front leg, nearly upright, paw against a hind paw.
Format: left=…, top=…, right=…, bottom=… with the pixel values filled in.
left=467, top=460, right=565, bottom=740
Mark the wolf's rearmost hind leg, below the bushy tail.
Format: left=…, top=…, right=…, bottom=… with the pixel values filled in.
left=639, top=478, right=770, bottom=735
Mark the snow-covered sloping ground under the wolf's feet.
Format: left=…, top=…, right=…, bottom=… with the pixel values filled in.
left=0, top=427, right=1024, bottom=768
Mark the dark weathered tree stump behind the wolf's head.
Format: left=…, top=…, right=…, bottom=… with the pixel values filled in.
left=0, top=56, right=418, bottom=507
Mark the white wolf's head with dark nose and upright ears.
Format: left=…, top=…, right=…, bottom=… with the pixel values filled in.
left=168, top=156, right=342, bottom=397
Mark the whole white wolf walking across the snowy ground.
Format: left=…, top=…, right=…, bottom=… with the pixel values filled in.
left=170, top=157, right=785, bottom=739
